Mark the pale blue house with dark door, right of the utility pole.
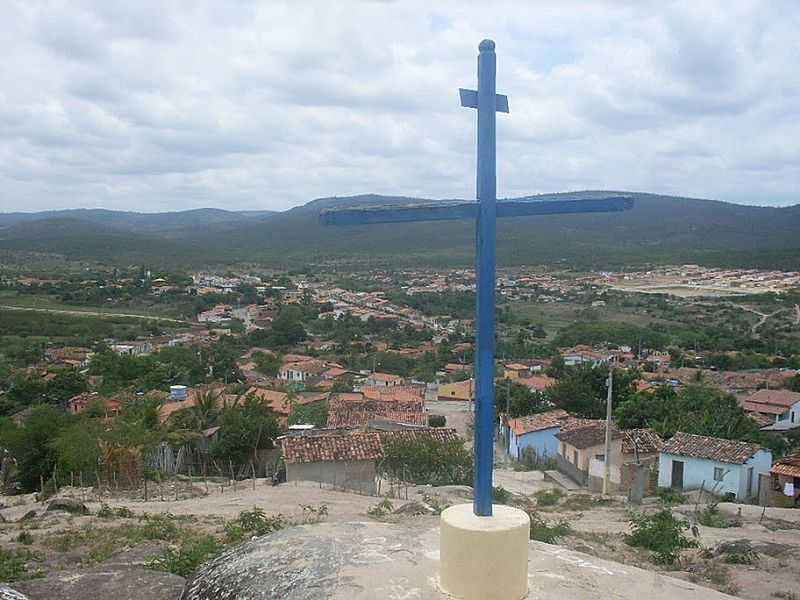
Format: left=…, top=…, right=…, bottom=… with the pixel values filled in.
left=658, top=432, right=772, bottom=499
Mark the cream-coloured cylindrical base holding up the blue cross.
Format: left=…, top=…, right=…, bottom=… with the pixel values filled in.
left=439, top=504, right=531, bottom=600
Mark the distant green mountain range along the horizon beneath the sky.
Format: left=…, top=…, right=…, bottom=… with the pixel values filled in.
left=0, top=191, right=800, bottom=269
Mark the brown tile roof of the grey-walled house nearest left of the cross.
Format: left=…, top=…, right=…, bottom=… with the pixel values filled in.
left=281, top=433, right=383, bottom=464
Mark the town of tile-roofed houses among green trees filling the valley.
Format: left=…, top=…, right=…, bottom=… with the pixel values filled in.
left=0, top=265, right=800, bottom=598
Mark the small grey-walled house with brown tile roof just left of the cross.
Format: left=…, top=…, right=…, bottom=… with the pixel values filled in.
left=281, top=433, right=383, bottom=495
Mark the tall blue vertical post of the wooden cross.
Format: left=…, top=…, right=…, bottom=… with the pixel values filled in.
left=473, top=40, right=497, bottom=516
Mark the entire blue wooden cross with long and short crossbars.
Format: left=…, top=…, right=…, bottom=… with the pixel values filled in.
left=320, top=40, right=633, bottom=516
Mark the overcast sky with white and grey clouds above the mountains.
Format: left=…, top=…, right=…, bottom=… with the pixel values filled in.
left=0, top=0, right=800, bottom=211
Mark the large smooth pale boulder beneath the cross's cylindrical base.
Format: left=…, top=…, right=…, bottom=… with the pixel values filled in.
left=181, top=517, right=731, bottom=600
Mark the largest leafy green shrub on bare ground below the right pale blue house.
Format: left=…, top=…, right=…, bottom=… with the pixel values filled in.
left=625, top=508, right=698, bottom=565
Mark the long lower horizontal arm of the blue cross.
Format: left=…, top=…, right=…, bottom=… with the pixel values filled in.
left=319, top=196, right=633, bottom=225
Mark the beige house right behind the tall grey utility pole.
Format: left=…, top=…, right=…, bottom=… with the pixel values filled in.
left=555, top=420, right=622, bottom=490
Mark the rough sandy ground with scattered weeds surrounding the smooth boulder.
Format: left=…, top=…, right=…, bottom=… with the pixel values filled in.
left=0, top=469, right=800, bottom=600
